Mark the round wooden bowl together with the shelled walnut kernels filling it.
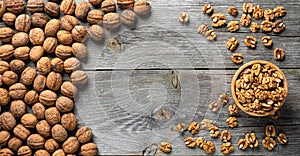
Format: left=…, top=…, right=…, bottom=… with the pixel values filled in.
left=231, top=60, right=288, bottom=117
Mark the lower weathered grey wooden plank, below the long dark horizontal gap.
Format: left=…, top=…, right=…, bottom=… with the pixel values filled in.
left=76, top=69, right=300, bottom=155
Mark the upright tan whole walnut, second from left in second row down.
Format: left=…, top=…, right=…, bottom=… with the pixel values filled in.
left=15, top=14, right=31, bottom=32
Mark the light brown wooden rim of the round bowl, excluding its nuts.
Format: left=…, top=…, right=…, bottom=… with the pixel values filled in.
left=231, top=60, right=288, bottom=117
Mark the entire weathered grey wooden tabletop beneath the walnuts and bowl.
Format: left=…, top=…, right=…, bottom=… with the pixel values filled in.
left=76, top=0, right=300, bottom=155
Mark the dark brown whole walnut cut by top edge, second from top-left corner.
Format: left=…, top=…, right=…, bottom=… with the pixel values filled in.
left=5, top=0, right=25, bottom=14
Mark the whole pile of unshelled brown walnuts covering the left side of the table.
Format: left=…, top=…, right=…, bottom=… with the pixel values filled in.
left=0, top=0, right=151, bottom=156
